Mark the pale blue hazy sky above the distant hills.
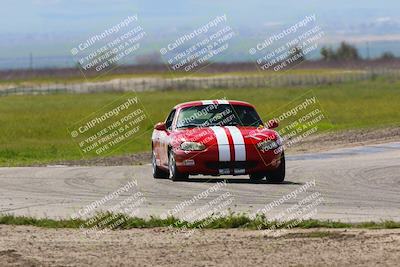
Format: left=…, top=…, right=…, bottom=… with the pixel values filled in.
left=0, top=0, right=400, bottom=34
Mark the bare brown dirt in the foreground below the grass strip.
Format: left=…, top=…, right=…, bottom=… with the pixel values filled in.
left=0, top=225, right=400, bottom=266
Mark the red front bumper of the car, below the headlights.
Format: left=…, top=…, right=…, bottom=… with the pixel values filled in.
left=175, top=145, right=283, bottom=175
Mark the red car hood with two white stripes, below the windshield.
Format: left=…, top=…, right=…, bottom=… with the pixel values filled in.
left=174, top=126, right=279, bottom=146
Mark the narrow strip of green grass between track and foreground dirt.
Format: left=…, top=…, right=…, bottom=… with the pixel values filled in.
left=0, top=213, right=400, bottom=230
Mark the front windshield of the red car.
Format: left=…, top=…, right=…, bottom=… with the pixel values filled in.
left=177, top=104, right=262, bottom=128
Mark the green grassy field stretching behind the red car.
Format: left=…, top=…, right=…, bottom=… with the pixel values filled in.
left=0, top=79, right=400, bottom=166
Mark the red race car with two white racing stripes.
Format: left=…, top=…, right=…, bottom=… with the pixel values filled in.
left=152, top=100, right=285, bottom=183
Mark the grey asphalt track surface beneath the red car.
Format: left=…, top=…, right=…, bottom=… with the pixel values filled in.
left=0, top=142, right=400, bottom=222
